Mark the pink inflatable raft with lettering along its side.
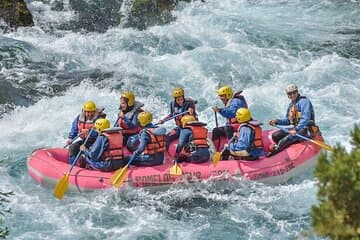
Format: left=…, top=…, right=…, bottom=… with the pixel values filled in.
left=27, top=130, right=322, bottom=191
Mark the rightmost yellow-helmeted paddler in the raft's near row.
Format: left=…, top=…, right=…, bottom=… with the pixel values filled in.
left=223, top=108, right=265, bottom=161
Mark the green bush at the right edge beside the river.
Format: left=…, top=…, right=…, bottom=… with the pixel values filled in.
left=312, top=125, right=360, bottom=240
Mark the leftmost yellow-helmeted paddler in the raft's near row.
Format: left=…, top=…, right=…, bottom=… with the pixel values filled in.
left=80, top=118, right=127, bottom=172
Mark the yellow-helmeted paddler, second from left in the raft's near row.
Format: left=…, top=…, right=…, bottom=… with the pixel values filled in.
left=126, top=111, right=166, bottom=166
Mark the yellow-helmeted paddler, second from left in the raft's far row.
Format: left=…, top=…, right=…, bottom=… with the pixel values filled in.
left=115, top=91, right=144, bottom=145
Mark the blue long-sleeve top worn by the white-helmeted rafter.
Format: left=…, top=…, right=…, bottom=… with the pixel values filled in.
left=276, top=96, right=314, bottom=131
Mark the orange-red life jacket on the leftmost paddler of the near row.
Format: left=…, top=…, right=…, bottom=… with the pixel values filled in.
left=101, top=129, right=124, bottom=161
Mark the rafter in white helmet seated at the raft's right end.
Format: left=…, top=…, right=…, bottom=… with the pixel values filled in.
left=267, top=84, right=320, bottom=156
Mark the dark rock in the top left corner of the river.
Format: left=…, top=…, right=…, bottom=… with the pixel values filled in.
left=0, top=0, right=34, bottom=28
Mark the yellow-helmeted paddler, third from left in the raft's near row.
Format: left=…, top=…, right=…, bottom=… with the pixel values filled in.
left=175, top=115, right=210, bottom=163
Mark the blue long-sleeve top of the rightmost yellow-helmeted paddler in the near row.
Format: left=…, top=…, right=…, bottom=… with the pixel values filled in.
left=229, top=126, right=265, bottom=156
